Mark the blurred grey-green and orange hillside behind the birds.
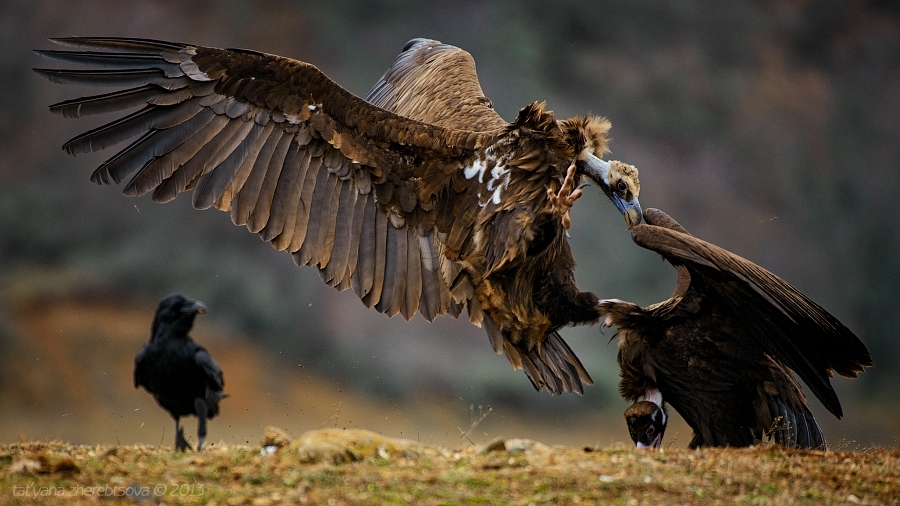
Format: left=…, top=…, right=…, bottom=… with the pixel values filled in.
left=0, top=0, right=900, bottom=448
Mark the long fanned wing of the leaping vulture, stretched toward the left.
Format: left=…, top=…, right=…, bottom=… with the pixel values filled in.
left=35, top=38, right=502, bottom=321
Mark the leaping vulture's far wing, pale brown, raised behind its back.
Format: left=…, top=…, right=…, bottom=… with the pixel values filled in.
left=366, top=39, right=507, bottom=132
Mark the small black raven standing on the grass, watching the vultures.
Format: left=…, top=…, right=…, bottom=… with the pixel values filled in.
left=134, top=294, right=226, bottom=451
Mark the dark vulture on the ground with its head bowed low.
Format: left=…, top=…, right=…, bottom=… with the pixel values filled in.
left=599, top=209, right=872, bottom=449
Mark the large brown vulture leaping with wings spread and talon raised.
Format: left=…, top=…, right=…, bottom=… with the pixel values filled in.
left=36, top=38, right=640, bottom=393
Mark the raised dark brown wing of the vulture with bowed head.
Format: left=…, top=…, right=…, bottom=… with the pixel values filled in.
left=632, top=209, right=872, bottom=417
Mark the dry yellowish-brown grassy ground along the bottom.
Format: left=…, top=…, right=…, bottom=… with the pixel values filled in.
left=0, top=429, right=900, bottom=505
